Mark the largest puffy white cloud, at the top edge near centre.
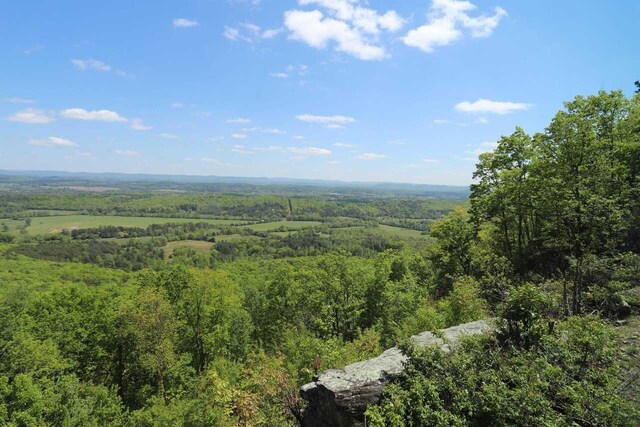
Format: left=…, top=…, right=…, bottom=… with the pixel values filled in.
left=285, top=0, right=404, bottom=61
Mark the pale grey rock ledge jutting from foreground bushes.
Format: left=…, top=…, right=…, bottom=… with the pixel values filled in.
left=301, top=320, right=492, bottom=427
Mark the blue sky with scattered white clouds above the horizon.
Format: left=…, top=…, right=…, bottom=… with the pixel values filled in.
left=0, top=0, right=640, bottom=185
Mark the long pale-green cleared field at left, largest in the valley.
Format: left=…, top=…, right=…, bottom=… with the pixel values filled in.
left=27, top=215, right=239, bottom=234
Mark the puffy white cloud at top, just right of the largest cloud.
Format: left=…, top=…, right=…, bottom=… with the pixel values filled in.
left=402, top=0, right=507, bottom=53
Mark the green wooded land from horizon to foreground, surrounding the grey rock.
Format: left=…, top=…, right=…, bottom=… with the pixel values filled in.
left=0, top=87, right=640, bottom=427
